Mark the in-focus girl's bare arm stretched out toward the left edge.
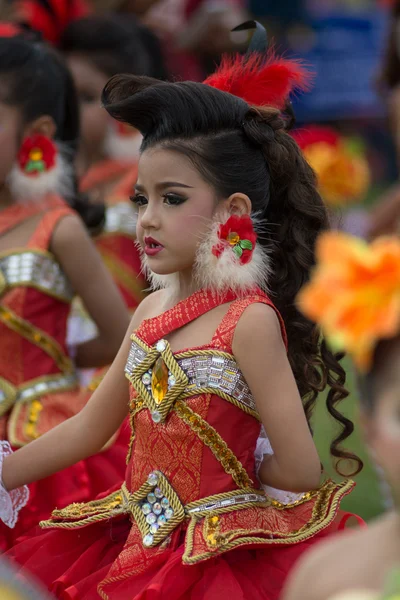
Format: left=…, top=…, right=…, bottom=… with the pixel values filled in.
left=3, top=294, right=156, bottom=490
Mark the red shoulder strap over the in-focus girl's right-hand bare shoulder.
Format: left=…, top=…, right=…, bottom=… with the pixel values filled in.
left=211, top=291, right=288, bottom=351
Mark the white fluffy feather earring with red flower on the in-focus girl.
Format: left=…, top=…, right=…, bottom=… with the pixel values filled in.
left=194, top=215, right=270, bottom=295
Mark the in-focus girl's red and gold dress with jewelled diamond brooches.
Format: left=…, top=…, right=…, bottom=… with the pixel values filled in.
left=12, top=290, right=352, bottom=600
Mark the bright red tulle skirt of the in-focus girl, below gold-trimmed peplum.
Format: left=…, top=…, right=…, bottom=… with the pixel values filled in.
left=9, top=510, right=346, bottom=600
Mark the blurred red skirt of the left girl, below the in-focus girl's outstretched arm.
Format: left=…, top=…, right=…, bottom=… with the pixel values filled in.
left=0, top=421, right=130, bottom=552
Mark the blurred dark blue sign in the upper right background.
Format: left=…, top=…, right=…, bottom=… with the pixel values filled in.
left=293, top=9, right=387, bottom=122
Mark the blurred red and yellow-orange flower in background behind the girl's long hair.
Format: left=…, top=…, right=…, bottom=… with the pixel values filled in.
left=293, top=126, right=371, bottom=207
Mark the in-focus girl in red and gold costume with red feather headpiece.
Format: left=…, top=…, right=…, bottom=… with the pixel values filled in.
left=1, top=23, right=360, bottom=600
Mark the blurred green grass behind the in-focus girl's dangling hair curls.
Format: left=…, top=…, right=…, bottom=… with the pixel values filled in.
left=313, top=363, right=384, bottom=521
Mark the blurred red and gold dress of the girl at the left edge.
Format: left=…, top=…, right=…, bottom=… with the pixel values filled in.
left=0, top=197, right=126, bottom=549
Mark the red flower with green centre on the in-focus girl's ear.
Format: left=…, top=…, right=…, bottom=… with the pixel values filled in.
left=212, top=215, right=257, bottom=265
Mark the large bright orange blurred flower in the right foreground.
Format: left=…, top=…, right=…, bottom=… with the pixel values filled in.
left=297, top=232, right=400, bottom=370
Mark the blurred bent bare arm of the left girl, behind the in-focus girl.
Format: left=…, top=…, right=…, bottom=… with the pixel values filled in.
left=51, top=215, right=133, bottom=368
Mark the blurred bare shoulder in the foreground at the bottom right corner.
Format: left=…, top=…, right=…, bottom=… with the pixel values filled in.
left=282, top=515, right=396, bottom=600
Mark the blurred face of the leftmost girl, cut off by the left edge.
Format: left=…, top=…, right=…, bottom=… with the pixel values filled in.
left=0, top=102, right=21, bottom=187
